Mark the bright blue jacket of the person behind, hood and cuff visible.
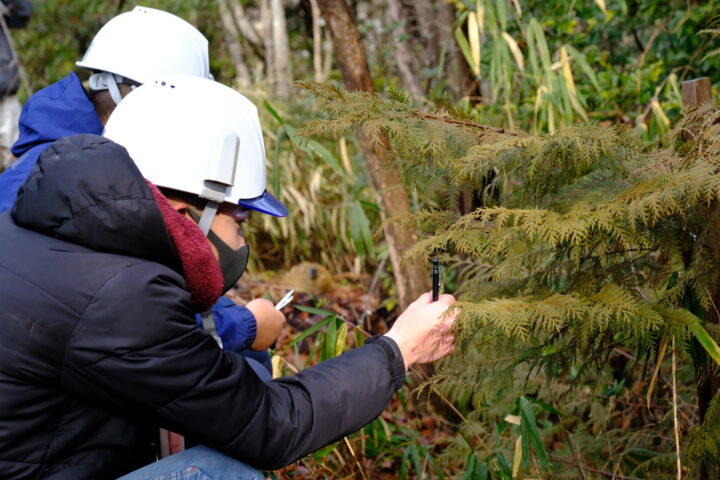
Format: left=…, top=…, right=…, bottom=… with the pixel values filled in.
left=0, top=73, right=257, bottom=352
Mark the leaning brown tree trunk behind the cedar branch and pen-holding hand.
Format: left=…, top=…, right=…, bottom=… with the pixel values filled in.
left=318, top=0, right=429, bottom=308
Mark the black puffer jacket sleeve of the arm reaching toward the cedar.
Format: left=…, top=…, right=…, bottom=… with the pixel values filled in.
left=62, top=264, right=404, bottom=469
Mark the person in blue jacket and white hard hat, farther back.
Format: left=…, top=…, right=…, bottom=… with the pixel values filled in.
left=0, top=6, right=285, bottom=379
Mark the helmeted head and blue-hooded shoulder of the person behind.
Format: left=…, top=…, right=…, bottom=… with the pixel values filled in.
left=0, top=6, right=212, bottom=212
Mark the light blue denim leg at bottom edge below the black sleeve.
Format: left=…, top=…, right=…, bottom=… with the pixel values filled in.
left=118, top=446, right=265, bottom=480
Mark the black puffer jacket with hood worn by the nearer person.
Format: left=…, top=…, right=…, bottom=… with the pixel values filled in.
left=0, top=135, right=404, bottom=480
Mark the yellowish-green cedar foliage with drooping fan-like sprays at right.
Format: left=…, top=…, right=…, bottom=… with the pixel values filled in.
left=304, top=84, right=720, bottom=478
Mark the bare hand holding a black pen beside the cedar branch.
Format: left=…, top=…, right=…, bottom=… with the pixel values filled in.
left=385, top=292, right=458, bottom=370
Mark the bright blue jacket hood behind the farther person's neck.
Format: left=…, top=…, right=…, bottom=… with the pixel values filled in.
left=12, top=73, right=103, bottom=158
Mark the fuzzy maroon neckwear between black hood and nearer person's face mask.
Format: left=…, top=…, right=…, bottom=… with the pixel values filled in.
left=145, top=180, right=223, bottom=312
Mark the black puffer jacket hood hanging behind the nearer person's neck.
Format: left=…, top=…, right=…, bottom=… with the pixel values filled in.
left=12, top=135, right=182, bottom=273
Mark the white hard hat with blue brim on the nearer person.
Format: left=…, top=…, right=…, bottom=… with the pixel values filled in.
left=103, top=76, right=287, bottom=222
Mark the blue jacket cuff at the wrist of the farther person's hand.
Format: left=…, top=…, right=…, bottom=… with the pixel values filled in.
left=195, top=296, right=257, bottom=352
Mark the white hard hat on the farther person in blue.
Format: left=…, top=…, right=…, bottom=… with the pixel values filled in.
left=76, top=7, right=212, bottom=84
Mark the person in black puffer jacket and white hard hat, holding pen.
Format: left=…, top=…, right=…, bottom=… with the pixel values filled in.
left=0, top=77, right=456, bottom=480
